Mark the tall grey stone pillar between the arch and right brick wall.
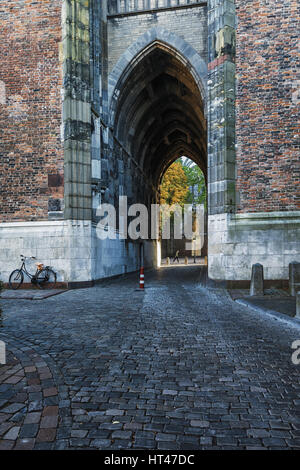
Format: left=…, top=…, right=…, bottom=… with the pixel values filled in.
left=207, top=0, right=236, bottom=214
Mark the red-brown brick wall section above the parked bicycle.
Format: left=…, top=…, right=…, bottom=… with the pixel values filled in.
left=0, top=0, right=63, bottom=222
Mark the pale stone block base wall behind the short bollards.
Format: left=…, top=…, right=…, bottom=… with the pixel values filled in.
left=208, top=211, right=300, bottom=281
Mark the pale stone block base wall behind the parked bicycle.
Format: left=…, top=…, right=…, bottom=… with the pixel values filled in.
left=0, top=220, right=157, bottom=287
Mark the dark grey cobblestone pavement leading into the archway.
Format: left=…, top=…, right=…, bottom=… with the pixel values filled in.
left=0, top=266, right=300, bottom=450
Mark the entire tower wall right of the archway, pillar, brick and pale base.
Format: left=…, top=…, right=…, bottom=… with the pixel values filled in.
left=208, top=0, right=300, bottom=281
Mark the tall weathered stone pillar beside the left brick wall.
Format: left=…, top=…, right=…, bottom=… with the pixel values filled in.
left=62, top=0, right=92, bottom=221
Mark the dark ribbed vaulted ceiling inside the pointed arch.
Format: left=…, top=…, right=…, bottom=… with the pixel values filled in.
left=115, top=46, right=207, bottom=186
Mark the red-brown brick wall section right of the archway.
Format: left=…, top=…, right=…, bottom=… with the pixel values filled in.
left=236, top=0, right=300, bottom=212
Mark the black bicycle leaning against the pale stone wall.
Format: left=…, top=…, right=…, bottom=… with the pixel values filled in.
left=8, top=255, right=56, bottom=290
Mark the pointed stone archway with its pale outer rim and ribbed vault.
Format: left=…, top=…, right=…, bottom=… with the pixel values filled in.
left=108, top=28, right=207, bottom=268
